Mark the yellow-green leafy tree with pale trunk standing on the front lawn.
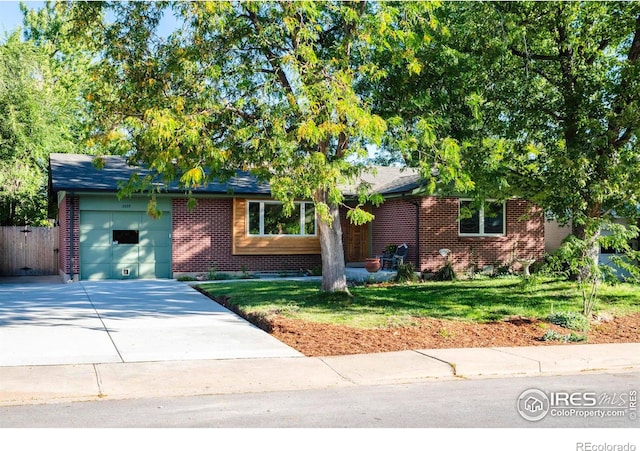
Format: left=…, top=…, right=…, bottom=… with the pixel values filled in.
left=72, top=1, right=435, bottom=292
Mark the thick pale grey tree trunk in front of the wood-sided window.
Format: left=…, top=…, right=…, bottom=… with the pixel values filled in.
left=318, top=192, right=349, bottom=293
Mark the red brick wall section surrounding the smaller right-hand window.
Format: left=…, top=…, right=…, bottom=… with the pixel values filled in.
left=420, top=197, right=544, bottom=271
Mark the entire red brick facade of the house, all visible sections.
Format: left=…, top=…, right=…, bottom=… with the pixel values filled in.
left=58, top=192, right=545, bottom=278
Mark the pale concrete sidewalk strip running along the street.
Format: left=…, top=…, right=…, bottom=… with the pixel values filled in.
left=0, top=343, right=640, bottom=406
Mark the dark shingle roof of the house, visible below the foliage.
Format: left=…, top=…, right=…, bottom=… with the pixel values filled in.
left=49, top=153, right=421, bottom=196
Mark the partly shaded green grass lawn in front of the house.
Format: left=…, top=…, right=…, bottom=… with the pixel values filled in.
left=200, top=278, right=640, bottom=328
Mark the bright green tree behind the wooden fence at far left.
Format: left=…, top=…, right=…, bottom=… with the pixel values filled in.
left=0, top=4, right=88, bottom=225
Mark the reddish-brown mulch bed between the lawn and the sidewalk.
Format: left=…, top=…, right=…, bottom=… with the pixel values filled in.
left=269, top=314, right=640, bottom=357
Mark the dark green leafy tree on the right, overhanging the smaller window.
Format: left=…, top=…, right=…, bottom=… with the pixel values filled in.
left=371, top=2, right=640, bottom=282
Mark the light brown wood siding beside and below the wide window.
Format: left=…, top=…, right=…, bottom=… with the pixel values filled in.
left=232, top=199, right=320, bottom=255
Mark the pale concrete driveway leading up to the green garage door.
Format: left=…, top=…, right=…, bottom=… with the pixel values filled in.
left=0, top=280, right=302, bottom=366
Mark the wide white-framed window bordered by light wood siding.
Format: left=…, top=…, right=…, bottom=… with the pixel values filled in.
left=247, top=201, right=316, bottom=236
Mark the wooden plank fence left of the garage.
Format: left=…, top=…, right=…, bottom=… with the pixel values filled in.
left=0, top=227, right=59, bottom=276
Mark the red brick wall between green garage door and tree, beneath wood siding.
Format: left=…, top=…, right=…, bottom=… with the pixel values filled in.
left=172, top=199, right=320, bottom=273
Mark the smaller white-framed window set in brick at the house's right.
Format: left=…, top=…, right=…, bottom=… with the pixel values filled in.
left=459, top=200, right=505, bottom=236
